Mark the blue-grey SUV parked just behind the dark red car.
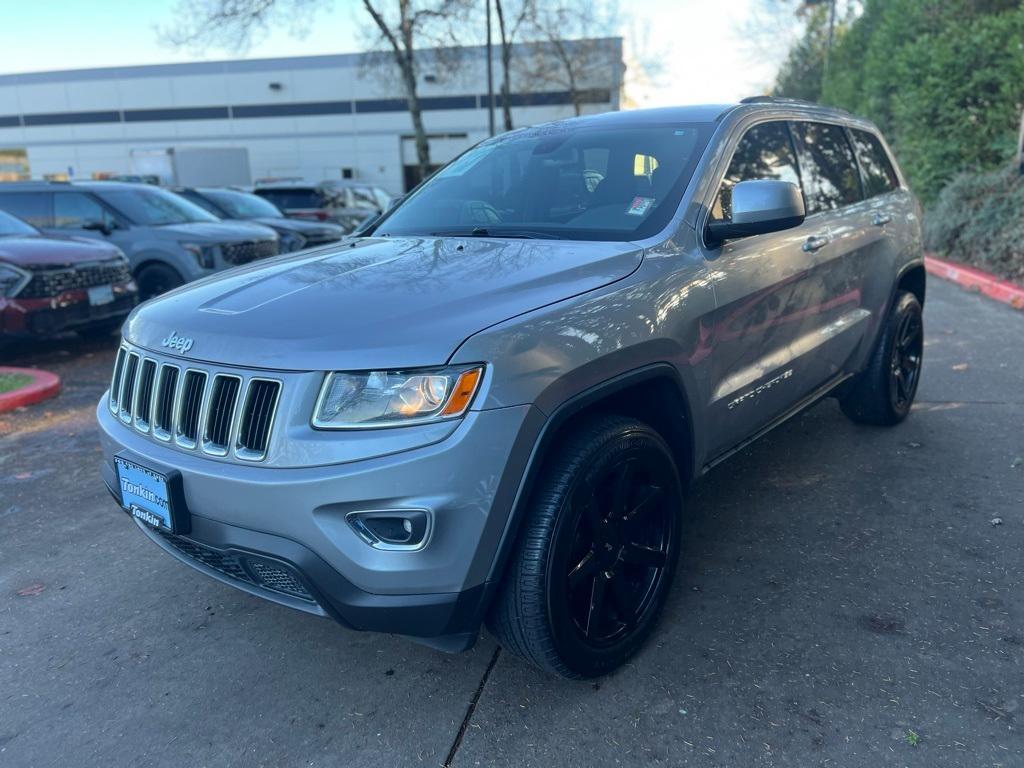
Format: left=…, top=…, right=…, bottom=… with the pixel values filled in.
left=0, top=181, right=280, bottom=299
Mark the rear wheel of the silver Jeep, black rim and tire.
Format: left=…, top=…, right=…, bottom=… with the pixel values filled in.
left=840, top=291, right=925, bottom=426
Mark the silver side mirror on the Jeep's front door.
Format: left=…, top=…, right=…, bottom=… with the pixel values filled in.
left=708, top=179, right=806, bottom=243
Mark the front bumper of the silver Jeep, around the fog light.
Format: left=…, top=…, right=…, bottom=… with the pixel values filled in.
left=97, top=399, right=543, bottom=650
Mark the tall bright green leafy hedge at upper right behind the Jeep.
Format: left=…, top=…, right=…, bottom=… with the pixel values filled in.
left=776, top=0, right=1024, bottom=205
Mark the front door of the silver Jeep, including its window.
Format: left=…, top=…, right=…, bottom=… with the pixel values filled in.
left=706, top=120, right=833, bottom=458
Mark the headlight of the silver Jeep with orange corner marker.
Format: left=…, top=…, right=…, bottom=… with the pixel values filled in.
left=313, top=366, right=483, bottom=429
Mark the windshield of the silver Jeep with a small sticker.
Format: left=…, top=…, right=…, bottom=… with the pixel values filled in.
left=373, top=123, right=710, bottom=241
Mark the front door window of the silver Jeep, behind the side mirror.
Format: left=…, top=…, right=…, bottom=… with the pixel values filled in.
left=711, top=122, right=800, bottom=221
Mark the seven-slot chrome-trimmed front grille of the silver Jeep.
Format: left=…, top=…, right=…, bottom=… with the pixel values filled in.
left=109, top=343, right=284, bottom=462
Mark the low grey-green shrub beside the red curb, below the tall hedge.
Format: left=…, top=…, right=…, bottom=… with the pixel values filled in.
left=925, top=164, right=1024, bottom=283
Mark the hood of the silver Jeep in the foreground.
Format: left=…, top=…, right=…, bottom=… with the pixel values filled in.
left=125, top=238, right=643, bottom=371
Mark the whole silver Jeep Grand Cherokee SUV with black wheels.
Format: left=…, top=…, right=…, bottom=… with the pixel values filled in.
left=96, top=98, right=925, bottom=677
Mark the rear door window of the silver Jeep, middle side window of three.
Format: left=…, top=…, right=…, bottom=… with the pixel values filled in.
left=795, top=123, right=861, bottom=215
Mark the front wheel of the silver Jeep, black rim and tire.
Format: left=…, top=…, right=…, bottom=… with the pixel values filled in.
left=487, top=416, right=683, bottom=678
